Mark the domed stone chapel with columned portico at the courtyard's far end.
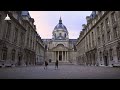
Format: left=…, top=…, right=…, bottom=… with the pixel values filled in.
left=43, top=18, right=77, bottom=63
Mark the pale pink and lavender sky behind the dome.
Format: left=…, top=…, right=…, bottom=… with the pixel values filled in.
left=29, top=11, right=92, bottom=39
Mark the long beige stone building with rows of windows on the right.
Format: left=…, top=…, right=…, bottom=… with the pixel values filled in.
left=76, top=11, right=120, bottom=66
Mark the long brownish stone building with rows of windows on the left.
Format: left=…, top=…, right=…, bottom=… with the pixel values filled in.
left=0, top=11, right=44, bottom=67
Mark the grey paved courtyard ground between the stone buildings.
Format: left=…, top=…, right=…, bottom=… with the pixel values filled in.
left=0, top=65, right=120, bottom=79
